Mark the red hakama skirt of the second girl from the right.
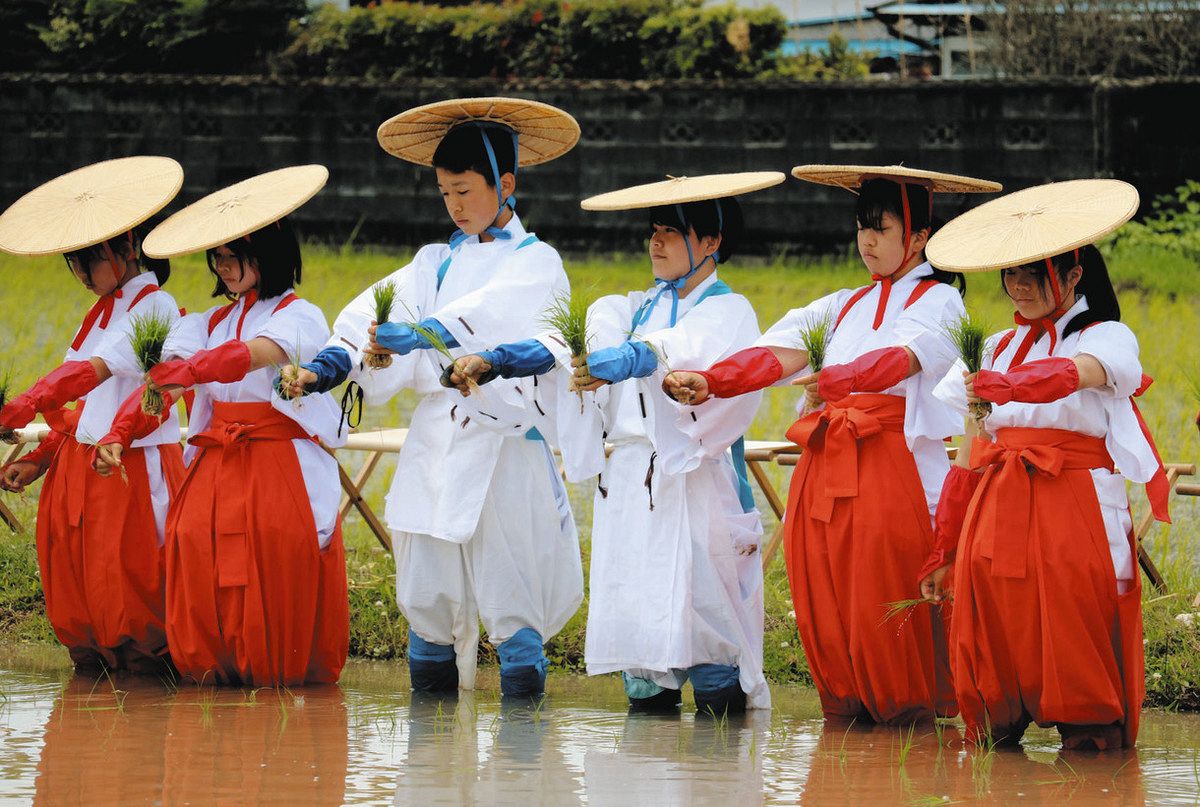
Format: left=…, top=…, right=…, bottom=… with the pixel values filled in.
left=785, top=394, right=956, bottom=723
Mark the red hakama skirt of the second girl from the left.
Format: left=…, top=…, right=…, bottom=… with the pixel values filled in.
left=167, top=402, right=349, bottom=686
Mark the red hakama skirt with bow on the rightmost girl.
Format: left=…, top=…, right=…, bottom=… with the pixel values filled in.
left=950, top=429, right=1145, bottom=747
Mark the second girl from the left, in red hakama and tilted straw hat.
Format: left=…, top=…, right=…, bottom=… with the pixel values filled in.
left=101, top=166, right=349, bottom=686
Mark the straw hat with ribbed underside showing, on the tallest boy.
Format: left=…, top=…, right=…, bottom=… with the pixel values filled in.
left=377, top=97, right=580, bottom=166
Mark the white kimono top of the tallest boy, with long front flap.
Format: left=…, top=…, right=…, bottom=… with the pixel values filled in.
left=328, top=215, right=570, bottom=543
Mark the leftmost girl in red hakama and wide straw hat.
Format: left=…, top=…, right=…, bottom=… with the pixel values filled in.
left=0, top=157, right=184, bottom=673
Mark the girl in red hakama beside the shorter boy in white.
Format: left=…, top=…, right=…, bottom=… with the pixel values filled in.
left=665, top=166, right=998, bottom=723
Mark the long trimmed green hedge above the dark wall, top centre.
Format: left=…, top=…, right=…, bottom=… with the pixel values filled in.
left=275, top=0, right=786, bottom=79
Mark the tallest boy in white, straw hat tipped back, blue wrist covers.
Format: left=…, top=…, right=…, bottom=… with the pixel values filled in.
left=284, top=98, right=583, bottom=697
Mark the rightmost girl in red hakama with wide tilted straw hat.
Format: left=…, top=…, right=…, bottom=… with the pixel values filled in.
left=922, top=180, right=1169, bottom=751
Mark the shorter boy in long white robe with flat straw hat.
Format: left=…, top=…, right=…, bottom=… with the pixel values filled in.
left=451, top=172, right=784, bottom=715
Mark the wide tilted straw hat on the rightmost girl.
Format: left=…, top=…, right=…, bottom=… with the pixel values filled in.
left=925, top=179, right=1138, bottom=271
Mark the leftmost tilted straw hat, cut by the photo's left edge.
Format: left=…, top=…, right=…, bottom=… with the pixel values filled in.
left=0, top=157, right=184, bottom=255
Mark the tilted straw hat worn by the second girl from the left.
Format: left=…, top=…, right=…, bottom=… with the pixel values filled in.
left=142, top=165, right=329, bottom=258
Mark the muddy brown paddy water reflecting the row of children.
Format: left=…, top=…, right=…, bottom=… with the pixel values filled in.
left=0, top=663, right=1200, bottom=807
